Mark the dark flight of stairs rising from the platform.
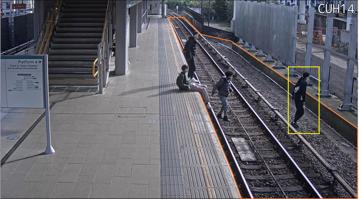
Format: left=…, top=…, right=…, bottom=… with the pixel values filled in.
left=48, top=0, right=107, bottom=86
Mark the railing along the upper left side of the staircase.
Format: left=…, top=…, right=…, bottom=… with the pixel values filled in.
left=35, top=0, right=62, bottom=54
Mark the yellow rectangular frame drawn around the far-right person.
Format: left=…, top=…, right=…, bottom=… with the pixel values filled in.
left=287, top=66, right=320, bottom=134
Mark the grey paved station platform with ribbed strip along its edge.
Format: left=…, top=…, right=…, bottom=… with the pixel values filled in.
left=1, top=17, right=240, bottom=198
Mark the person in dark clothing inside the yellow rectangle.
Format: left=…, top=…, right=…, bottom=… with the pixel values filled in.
left=291, top=72, right=309, bottom=128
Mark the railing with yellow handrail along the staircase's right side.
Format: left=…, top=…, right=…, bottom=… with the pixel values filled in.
left=92, top=0, right=113, bottom=94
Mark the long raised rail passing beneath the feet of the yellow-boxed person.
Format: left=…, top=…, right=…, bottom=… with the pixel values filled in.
left=181, top=15, right=356, bottom=197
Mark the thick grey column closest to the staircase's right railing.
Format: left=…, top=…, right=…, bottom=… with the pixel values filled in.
left=115, top=1, right=129, bottom=75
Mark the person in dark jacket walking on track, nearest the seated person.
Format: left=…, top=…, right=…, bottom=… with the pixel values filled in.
left=212, top=71, right=233, bottom=122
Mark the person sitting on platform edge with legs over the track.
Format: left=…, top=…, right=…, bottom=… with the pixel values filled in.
left=176, top=65, right=209, bottom=108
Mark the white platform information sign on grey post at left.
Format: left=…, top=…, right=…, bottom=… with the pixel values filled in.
left=1, top=55, right=55, bottom=154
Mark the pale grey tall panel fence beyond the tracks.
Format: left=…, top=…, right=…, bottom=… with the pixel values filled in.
left=234, top=1, right=297, bottom=64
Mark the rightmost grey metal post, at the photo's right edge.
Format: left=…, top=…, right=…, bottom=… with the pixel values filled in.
left=339, top=17, right=358, bottom=111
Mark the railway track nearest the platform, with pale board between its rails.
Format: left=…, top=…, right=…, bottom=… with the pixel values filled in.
left=169, top=13, right=354, bottom=197
